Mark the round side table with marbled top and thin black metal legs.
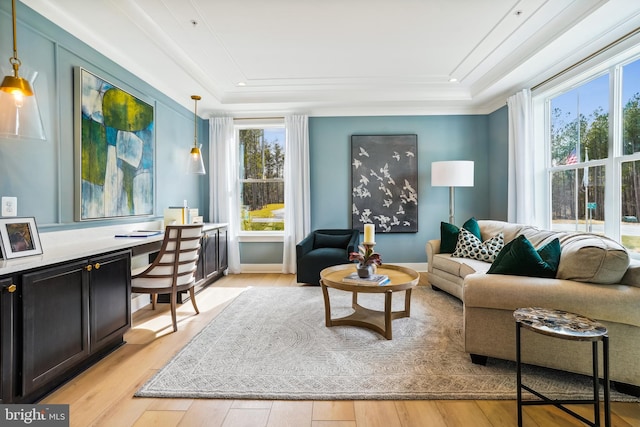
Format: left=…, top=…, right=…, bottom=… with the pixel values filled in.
left=513, top=307, right=611, bottom=427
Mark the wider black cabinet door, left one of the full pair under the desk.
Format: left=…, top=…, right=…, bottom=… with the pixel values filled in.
left=22, top=260, right=89, bottom=396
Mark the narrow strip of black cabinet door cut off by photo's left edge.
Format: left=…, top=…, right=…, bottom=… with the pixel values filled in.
left=0, top=277, right=17, bottom=404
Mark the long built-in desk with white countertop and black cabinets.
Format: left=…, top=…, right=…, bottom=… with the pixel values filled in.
left=0, top=223, right=227, bottom=404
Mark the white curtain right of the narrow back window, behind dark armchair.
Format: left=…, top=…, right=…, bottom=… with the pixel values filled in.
left=282, top=115, right=311, bottom=273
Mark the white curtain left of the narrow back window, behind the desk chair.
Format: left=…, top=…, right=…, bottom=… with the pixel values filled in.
left=209, top=117, right=240, bottom=274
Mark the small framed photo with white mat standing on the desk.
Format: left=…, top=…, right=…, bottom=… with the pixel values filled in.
left=0, top=217, right=42, bottom=259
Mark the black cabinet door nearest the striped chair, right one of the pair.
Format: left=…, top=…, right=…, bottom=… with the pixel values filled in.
left=89, top=251, right=131, bottom=353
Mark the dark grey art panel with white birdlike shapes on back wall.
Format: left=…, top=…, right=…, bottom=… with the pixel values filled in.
left=351, top=135, right=418, bottom=233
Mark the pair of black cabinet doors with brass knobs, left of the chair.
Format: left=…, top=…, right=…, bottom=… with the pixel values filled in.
left=21, top=251, right=131, bottom=400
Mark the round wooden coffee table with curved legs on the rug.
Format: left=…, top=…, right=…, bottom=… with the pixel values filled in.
left=320, top=264, right=420, bottom=340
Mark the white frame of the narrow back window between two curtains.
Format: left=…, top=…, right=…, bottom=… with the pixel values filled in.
left=233, top=118, right=287, bottom=242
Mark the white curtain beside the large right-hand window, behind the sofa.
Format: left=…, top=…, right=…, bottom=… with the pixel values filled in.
left=507, top=89, right=535, bottom=224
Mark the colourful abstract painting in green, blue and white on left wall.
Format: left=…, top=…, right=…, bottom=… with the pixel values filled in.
left=74, top=67, right=155, bottom=221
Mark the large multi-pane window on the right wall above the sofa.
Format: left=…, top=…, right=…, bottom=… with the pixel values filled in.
left=544, top=55, right=640, bottom=257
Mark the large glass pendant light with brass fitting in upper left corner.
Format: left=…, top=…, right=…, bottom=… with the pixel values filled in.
left=0, top=0, right=45, bottom=139
